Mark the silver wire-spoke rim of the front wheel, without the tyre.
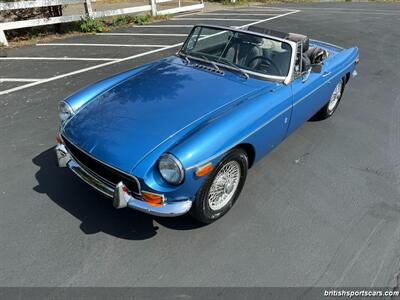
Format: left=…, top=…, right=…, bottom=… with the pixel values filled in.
left=208, top=161, right=241, bottom=211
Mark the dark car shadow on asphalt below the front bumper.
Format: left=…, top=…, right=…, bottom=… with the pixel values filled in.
left=32, top=148, right=202, bottom=240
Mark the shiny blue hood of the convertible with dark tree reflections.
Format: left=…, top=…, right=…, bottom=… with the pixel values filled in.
left=63, top=58, right=257, bottom=172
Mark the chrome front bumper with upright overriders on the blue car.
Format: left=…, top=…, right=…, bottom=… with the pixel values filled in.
left=55, top=144, right=192, bottom=217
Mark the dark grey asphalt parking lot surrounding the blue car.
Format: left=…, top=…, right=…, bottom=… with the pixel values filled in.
left=0, top=3, right=400, bottom=287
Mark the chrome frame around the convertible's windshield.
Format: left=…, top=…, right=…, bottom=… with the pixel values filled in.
left=177, top=24, right=297, bottom=85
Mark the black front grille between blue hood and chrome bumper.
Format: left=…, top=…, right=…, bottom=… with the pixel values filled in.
left=63, top=137, right=140, bottom=194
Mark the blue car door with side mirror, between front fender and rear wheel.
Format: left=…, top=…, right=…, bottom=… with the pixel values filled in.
left=288, top=61, right=335, bottom=134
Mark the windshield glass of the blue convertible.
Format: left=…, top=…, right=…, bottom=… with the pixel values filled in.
left=180, top=26, right=292, bottom=77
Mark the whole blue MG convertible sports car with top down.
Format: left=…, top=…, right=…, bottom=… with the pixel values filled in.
left=56, top=25, right=359, bottom=223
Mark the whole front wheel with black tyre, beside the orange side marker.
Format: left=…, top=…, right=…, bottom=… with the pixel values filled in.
left=190, top=149, right=248, bottom=224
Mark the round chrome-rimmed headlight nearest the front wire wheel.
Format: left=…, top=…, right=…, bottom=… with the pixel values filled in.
left=158, top=153, right=185, bottom=185
